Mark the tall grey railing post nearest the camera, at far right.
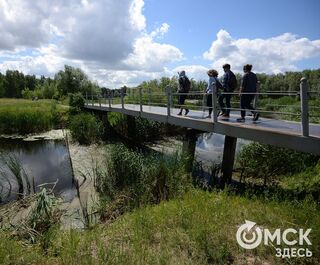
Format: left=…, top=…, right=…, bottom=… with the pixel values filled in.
left=300, top=77, right=309, bottom=137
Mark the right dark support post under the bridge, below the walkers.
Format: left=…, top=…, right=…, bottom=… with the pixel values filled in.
left=221, top=135, right=237, bottom=187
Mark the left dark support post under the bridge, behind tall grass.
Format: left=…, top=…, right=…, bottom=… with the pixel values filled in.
left=182, top=128, right=199, bottom=173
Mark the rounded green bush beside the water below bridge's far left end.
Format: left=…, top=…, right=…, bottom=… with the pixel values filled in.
left=69, top=113, right=103, bottom=144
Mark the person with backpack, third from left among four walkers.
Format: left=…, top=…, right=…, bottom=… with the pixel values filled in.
left=218, top=64, right=237, bottom=118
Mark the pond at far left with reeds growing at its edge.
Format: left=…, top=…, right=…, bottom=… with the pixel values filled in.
left=0, top=138, right=77, bottom=204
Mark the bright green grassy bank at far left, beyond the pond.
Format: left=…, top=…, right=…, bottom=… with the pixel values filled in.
left=0, top=99, right=68, bottom=134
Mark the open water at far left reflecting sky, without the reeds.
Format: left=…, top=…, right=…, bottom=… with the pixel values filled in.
left=0, top=138, right=77, bottom=203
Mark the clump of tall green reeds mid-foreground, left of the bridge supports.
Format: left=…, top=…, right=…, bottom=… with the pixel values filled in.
left=96, top=145, right=191, bottom=219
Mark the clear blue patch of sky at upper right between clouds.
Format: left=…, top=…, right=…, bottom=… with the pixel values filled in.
left=144, top=0, right=320, bottom=68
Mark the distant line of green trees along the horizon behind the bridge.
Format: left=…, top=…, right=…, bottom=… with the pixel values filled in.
left=0, top=65, right=320, bottom=99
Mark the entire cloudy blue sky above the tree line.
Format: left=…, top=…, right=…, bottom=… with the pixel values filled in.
left=0, top=0, right=320, bottom=88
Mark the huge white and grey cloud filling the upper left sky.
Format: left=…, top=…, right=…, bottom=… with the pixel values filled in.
left=0, top=0, right=183, bottom=85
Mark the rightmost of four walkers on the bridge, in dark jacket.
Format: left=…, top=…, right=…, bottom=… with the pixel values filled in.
left=237, top=64, right=259, bottom=122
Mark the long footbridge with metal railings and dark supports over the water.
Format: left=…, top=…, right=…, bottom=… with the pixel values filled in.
left=85, top=78, right=320, bottom=183
